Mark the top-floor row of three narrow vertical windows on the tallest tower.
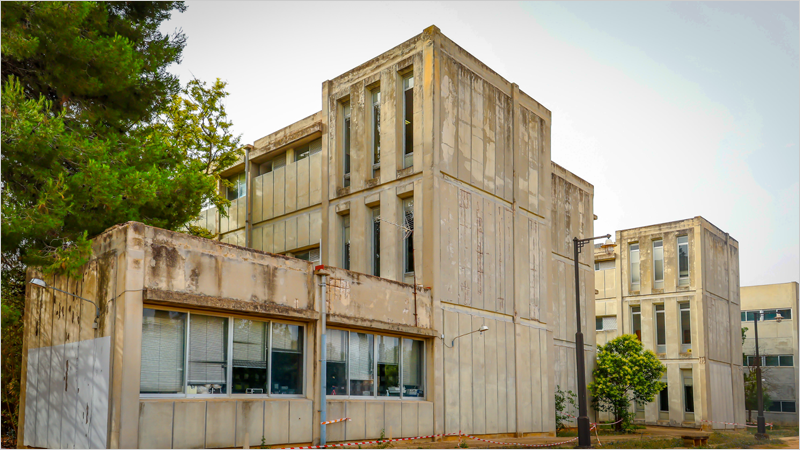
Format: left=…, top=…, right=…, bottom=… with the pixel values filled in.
left=341, top=72, right=414, bottom=187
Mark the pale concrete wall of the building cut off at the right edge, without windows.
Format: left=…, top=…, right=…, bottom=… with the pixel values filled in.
left=741, top=282, right=800, bottom=425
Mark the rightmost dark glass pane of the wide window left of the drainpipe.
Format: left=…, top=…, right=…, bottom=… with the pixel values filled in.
left=270, top=323, right=303, bottom=394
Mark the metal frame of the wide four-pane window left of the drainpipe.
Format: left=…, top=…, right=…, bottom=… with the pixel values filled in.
left=139, top=303, right=309, bottom=399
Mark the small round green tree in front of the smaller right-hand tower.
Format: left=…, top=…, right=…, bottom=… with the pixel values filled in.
left=589, top=334, right=667, bottom=431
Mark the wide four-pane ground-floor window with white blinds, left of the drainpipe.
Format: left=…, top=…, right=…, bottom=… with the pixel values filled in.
left=139, top=308, right=305, bottom=396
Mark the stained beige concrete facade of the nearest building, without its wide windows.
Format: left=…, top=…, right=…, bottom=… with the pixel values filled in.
left=18, top=27, right=595, bottom=448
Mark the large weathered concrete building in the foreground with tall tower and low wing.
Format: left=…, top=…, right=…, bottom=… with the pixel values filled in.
left=19, top=27, right=595, bottom=448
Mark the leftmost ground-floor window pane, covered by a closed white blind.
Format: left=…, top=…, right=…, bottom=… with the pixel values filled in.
left=139, top=308, right=186, bottom=394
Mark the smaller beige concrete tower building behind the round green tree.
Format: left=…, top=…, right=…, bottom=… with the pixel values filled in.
left=594, top=217, right=745, bottom=428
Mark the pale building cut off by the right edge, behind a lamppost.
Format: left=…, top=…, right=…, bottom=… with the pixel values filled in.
left=742, top=281, right=800, bottom=426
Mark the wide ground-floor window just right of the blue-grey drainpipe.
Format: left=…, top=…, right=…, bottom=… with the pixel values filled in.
left=326, top=329, right=425, bottom=398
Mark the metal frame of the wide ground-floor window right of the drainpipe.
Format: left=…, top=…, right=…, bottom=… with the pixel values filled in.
left=326, top=327, right=428, bottom=401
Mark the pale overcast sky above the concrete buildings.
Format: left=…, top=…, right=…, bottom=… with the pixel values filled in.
left=159, top=1, right=800, bottom=286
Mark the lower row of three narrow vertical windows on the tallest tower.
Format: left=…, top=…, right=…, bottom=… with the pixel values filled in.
left=342, top=197, right=414, bottom=276
